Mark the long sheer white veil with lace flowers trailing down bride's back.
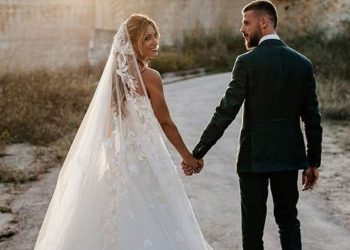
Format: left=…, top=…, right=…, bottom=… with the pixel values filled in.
left=35, top=21, right=147, bottom=250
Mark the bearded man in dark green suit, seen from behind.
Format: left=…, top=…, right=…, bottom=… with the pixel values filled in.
left=183, top=1, right=322, bottom=250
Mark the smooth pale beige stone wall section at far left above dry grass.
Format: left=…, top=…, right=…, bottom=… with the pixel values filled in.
left=0, top=0, right=94, bottom=74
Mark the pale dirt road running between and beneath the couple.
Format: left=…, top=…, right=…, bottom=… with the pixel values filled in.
left=166, top=73, right=350, bottom=250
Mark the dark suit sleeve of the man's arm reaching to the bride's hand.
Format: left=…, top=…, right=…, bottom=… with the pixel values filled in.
left=192, top=57, right=248, bottom=159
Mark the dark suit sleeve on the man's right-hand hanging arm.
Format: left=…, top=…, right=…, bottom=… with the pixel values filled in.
left=301, top=65, right=322, bottom=167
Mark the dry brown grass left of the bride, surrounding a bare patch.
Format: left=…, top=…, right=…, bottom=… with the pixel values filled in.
left=0, top=68, right=97, bottom=183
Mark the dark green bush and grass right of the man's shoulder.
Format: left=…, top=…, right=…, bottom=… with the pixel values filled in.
left=287, top=27, right=350, bottom=119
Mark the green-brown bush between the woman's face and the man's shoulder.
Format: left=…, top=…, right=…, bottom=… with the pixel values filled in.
left=152, top=28, right=245, bottom=73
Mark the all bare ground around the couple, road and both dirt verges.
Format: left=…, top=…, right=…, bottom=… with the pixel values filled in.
left=0, top=73, right=350, bottom=250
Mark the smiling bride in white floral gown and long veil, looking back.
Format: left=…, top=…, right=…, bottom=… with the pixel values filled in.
left=35, top=14, right=212, bottom=250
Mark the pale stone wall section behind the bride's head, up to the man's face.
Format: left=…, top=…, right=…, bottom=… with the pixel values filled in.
left=90, top=0, right=250, bottom=64
